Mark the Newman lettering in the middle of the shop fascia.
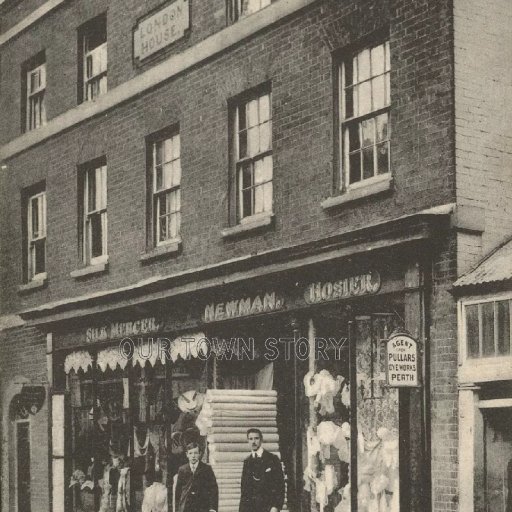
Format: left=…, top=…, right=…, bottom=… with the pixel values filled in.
left=204, top=292, right=284, bottom=322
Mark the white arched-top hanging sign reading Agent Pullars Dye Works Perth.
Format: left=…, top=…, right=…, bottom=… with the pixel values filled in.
left=386, top=333, right=419, bottom=388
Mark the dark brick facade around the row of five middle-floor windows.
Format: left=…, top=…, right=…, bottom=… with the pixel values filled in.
left=0, top=0, right=454, bottom=310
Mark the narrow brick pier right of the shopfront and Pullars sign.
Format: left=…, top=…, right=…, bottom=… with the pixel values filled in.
left=430, top=235, right=458, bottom=512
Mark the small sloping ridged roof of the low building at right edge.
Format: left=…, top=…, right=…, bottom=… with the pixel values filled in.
left=453, top=238, right=512, bottom=293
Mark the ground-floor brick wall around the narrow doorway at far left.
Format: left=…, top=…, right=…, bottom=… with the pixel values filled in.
left=0, top=327, right=50, bottom=512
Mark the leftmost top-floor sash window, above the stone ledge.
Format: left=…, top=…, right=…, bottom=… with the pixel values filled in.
left=22, top=52, right=46, bottom=131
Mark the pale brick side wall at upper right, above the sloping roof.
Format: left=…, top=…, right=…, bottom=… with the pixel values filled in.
left=454, top=0, right=512, bottom=256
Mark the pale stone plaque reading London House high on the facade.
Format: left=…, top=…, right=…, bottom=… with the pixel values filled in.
left=133, top=0, right=190, bottom=60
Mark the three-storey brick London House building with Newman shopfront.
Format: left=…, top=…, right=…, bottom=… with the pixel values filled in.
left=0, top=0, right=512, bottom=512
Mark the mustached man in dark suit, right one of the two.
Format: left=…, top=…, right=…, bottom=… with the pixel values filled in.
left=239, top=428, right=284, bottom=512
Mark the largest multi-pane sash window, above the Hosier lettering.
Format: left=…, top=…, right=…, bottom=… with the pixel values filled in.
left=340, top=42, right=391, bottom=189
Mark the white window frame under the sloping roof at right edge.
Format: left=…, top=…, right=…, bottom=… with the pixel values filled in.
left=457, top=292, right=512, bottom=383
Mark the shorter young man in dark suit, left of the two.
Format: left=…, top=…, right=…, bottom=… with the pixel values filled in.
left=175, top=443, right=219, bottom=512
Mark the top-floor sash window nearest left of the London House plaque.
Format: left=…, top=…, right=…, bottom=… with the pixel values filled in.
left=83, top=25, right=108, bottom=101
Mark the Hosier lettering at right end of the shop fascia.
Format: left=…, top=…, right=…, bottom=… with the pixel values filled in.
left=304, top=272, right=381, bottom=304
